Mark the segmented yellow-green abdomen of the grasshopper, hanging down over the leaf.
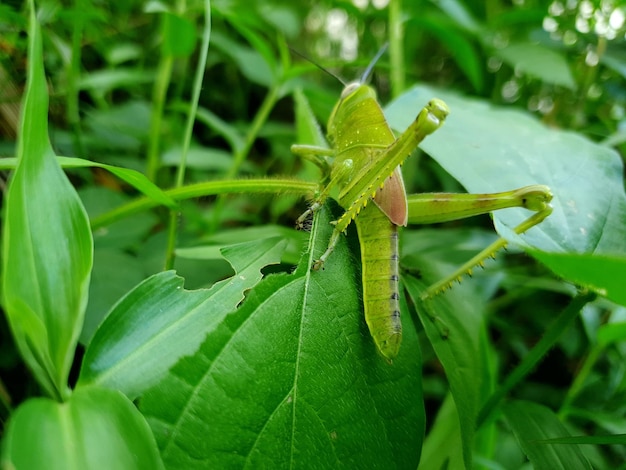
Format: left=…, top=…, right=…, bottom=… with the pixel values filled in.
left=355, top=201, right=402, bottom=360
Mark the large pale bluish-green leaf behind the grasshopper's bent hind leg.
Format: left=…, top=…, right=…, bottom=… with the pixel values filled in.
left=387, top=86, right=626, bottom=260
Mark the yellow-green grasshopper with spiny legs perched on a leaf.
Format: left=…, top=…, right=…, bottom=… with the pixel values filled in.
left=291, top=48, right=552, bottom=362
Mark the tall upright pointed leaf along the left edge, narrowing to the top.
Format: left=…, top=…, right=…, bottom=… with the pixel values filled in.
left=2, top=3, right=93, bottom=399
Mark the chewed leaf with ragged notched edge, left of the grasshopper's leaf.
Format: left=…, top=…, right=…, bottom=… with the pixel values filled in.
left=78, top=239, right=284, bottom=398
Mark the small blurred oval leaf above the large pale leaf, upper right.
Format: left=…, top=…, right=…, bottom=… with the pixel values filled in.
left=494, top=43, right=576, bottom=90
